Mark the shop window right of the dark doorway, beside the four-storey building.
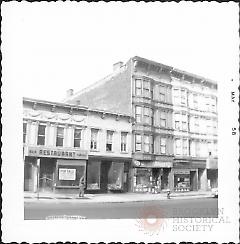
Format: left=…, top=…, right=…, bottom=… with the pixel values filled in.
left=108, top=162, right=124, bottom=190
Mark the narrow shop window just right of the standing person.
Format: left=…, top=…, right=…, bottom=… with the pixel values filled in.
left=87, top=161, right=101, bottom=190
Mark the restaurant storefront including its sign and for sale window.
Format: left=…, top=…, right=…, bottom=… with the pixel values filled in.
left=24, top=147, right=88, bottom=193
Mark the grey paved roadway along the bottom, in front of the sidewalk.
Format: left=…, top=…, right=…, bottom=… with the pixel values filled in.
left=24, top=198, right=218, bottom=220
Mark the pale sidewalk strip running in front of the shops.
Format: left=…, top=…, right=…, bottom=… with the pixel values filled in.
left=24, top=191, right=211, bottom=203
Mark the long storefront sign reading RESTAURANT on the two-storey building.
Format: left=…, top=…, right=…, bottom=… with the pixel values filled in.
left=26, top=147, right=88, bottom=159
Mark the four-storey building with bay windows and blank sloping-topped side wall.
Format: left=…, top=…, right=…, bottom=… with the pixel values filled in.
left=64, top=57, right=218, bottom=193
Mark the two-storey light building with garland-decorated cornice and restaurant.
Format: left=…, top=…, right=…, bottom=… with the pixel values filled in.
left=23, top=98, right=132, bottom=193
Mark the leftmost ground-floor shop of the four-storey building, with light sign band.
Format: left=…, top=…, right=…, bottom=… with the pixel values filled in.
left=133, top=161, right=172, bottom=193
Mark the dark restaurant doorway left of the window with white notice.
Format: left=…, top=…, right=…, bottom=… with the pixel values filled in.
left=39, top=158, right=56, bottom=192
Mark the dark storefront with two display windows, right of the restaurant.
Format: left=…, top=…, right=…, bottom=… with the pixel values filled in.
left=86, top=159, right=130, bottom=193
